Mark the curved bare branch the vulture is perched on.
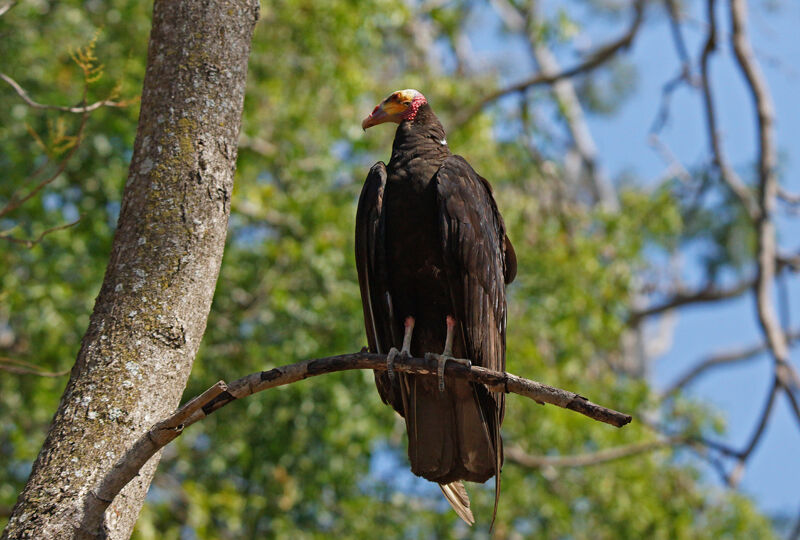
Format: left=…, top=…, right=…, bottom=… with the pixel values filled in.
left=82, top=352, right=632, bottom=532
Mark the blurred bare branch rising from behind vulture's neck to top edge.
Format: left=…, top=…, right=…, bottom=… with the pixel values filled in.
left=451, top=0, right=645, bottom=131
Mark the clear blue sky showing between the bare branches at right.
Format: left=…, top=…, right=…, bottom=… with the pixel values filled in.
left=472, top=0, right=800, bottom=516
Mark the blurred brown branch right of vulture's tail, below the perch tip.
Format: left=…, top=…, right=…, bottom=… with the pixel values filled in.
left=504, top=436, right=686, bottom=469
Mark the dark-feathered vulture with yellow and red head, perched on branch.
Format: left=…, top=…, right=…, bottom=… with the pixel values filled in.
left=355, top=89, right=517, bottom=525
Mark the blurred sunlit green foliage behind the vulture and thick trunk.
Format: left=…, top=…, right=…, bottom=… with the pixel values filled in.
left=0, top=0, right=771, bottom=539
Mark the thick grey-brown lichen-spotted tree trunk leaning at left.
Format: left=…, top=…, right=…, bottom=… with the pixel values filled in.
left=3, top=0, right=258, bottom=539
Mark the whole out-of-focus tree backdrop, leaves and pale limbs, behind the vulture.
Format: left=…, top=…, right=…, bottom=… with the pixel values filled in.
left=0, top=0, right=800, bottom=539
